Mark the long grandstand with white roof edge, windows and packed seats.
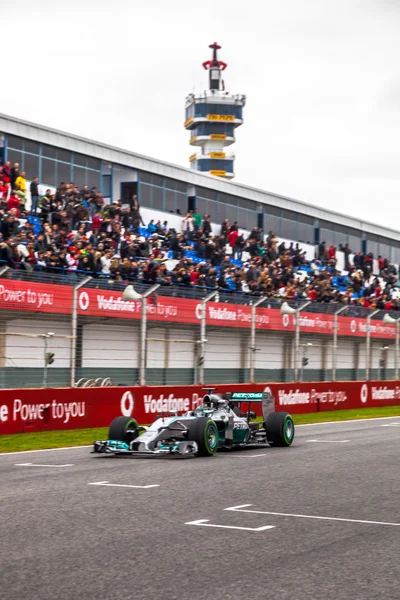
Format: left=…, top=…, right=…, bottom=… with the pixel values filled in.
left=0, top=115, right=400, bottom=310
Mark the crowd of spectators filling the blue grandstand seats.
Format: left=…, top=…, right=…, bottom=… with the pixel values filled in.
left=0, top=162, right=400, bottom=310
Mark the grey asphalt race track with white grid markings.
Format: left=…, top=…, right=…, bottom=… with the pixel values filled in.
left=0, top=417, right=400, bottom=600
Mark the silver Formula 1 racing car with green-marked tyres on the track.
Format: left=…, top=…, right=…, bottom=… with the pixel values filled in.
left=93, top=388, right=294, bottom=456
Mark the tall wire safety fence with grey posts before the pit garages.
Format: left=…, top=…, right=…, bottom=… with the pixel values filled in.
left=0, top=270, right=400, bottom=388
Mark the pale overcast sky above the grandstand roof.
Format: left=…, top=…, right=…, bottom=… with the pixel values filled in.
left=0, top=0, right=400, bottom=229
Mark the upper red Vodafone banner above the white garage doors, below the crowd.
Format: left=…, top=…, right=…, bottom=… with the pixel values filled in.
left=0, top=279, right=395, bottom=339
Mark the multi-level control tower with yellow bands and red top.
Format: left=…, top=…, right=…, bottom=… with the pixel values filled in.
left=184, top=42, right=246, bottom=179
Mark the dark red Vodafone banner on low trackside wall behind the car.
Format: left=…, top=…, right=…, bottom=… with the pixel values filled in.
left=0, top=381, right=400, bottom=435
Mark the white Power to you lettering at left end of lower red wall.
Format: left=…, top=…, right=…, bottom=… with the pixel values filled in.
left=0, top=399, right=85, bottom=423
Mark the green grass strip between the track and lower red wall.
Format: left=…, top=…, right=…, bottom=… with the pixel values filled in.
left=0, top=406, right=400, bottom=453
